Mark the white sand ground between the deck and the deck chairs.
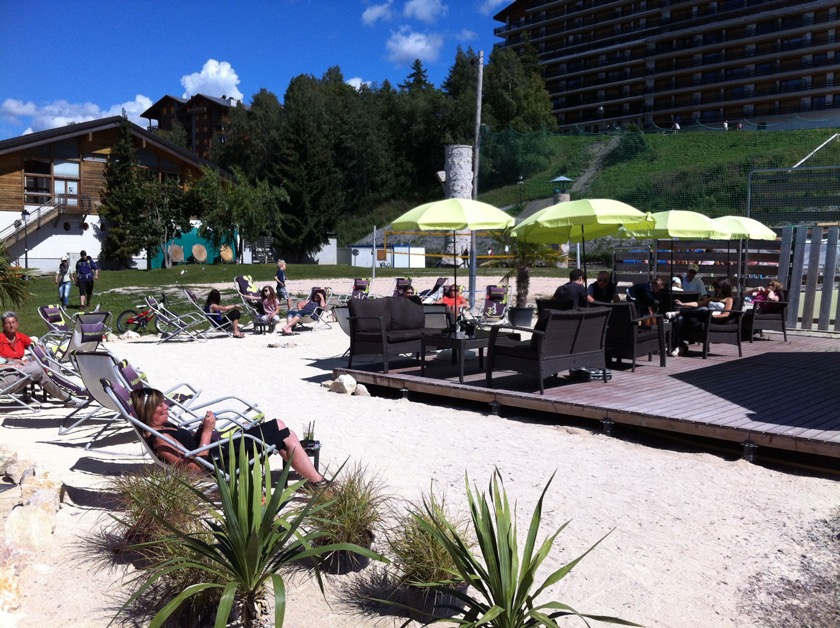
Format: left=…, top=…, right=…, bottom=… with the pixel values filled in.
left=0, top=280, right=840, bottom=628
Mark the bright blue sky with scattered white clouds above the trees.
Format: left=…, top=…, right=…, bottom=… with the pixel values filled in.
left=0, top=0, right=510, bottom=139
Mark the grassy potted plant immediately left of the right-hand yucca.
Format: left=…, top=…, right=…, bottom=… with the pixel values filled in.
left=386, top=492, right=469, bottom=622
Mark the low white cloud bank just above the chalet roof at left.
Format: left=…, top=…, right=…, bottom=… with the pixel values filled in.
left=0, top=94, right=152, bottom=135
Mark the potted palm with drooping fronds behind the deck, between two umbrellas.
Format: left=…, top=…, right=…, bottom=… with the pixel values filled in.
left=488, top=229, right=566, bottom=327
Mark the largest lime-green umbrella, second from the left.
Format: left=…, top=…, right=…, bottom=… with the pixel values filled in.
left=512, top=198, right=653, bottom=272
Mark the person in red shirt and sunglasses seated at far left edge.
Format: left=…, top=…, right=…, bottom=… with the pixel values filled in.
left=0, top=312, right=85, bottom=408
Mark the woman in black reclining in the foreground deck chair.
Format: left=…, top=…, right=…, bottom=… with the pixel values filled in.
left=131, top=388, right=324, bottom=484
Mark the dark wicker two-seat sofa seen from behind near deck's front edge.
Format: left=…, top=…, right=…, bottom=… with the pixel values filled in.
left=486, top=307, right=611, bottom=395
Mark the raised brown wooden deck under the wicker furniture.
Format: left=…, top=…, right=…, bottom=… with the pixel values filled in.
left=334, top=333, right=840, bottom=458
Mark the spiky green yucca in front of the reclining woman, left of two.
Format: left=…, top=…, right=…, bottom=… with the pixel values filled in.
left=117, top=441, right=380, bottom=628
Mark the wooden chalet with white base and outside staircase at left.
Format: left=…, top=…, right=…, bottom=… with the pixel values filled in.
left=0, top=116, right=210, bottom=270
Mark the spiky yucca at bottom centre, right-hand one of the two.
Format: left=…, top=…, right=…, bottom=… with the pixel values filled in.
left=418, top=470, right=638, bottom=628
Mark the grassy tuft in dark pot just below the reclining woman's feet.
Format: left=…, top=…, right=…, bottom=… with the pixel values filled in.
left=309, top=463, right=387, bottom=574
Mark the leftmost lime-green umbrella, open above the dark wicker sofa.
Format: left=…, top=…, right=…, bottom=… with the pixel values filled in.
left=391, top=198, right=516, bottom=300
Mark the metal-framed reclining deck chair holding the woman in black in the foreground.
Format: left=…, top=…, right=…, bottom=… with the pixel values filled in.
left=100, top=377, right=276, bottom=473
